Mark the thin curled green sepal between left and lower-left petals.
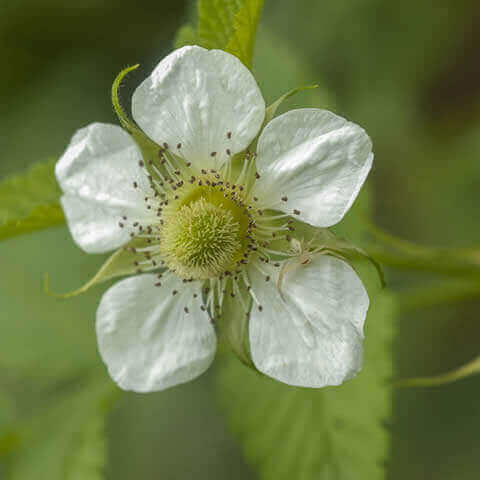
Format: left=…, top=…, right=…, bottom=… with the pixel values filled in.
left=45, top=238, right=159, bottom=298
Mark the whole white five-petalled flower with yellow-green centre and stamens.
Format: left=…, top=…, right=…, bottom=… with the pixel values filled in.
left=56, top=47, right=373, bottom=392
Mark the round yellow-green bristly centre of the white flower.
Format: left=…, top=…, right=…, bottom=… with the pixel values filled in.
left=160, top=196, right=244, bottom=279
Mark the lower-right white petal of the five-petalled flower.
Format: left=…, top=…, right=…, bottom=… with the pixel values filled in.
left=249, top=255, right=369, bottom=387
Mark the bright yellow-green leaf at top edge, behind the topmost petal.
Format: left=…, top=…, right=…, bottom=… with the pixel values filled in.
left=175, top=0, right=263, bottom=68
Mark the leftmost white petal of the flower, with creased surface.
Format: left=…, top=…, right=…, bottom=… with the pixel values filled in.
left=55, top=123, right=151, bottom=253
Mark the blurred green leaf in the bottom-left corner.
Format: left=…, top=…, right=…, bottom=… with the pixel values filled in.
left=0, top=380, right=113, bottom=480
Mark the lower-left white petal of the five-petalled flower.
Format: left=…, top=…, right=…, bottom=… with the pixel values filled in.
left=97, top=274, right=216, bottom=392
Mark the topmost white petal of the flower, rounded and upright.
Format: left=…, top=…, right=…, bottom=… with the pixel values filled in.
left=132, top=46, right=265, bottom=171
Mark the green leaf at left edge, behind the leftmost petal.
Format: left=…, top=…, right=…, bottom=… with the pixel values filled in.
left=0, top=161, right=65, bottom=240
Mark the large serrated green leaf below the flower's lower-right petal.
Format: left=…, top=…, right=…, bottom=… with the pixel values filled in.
left=218, top=292, right=396, bottom=480
